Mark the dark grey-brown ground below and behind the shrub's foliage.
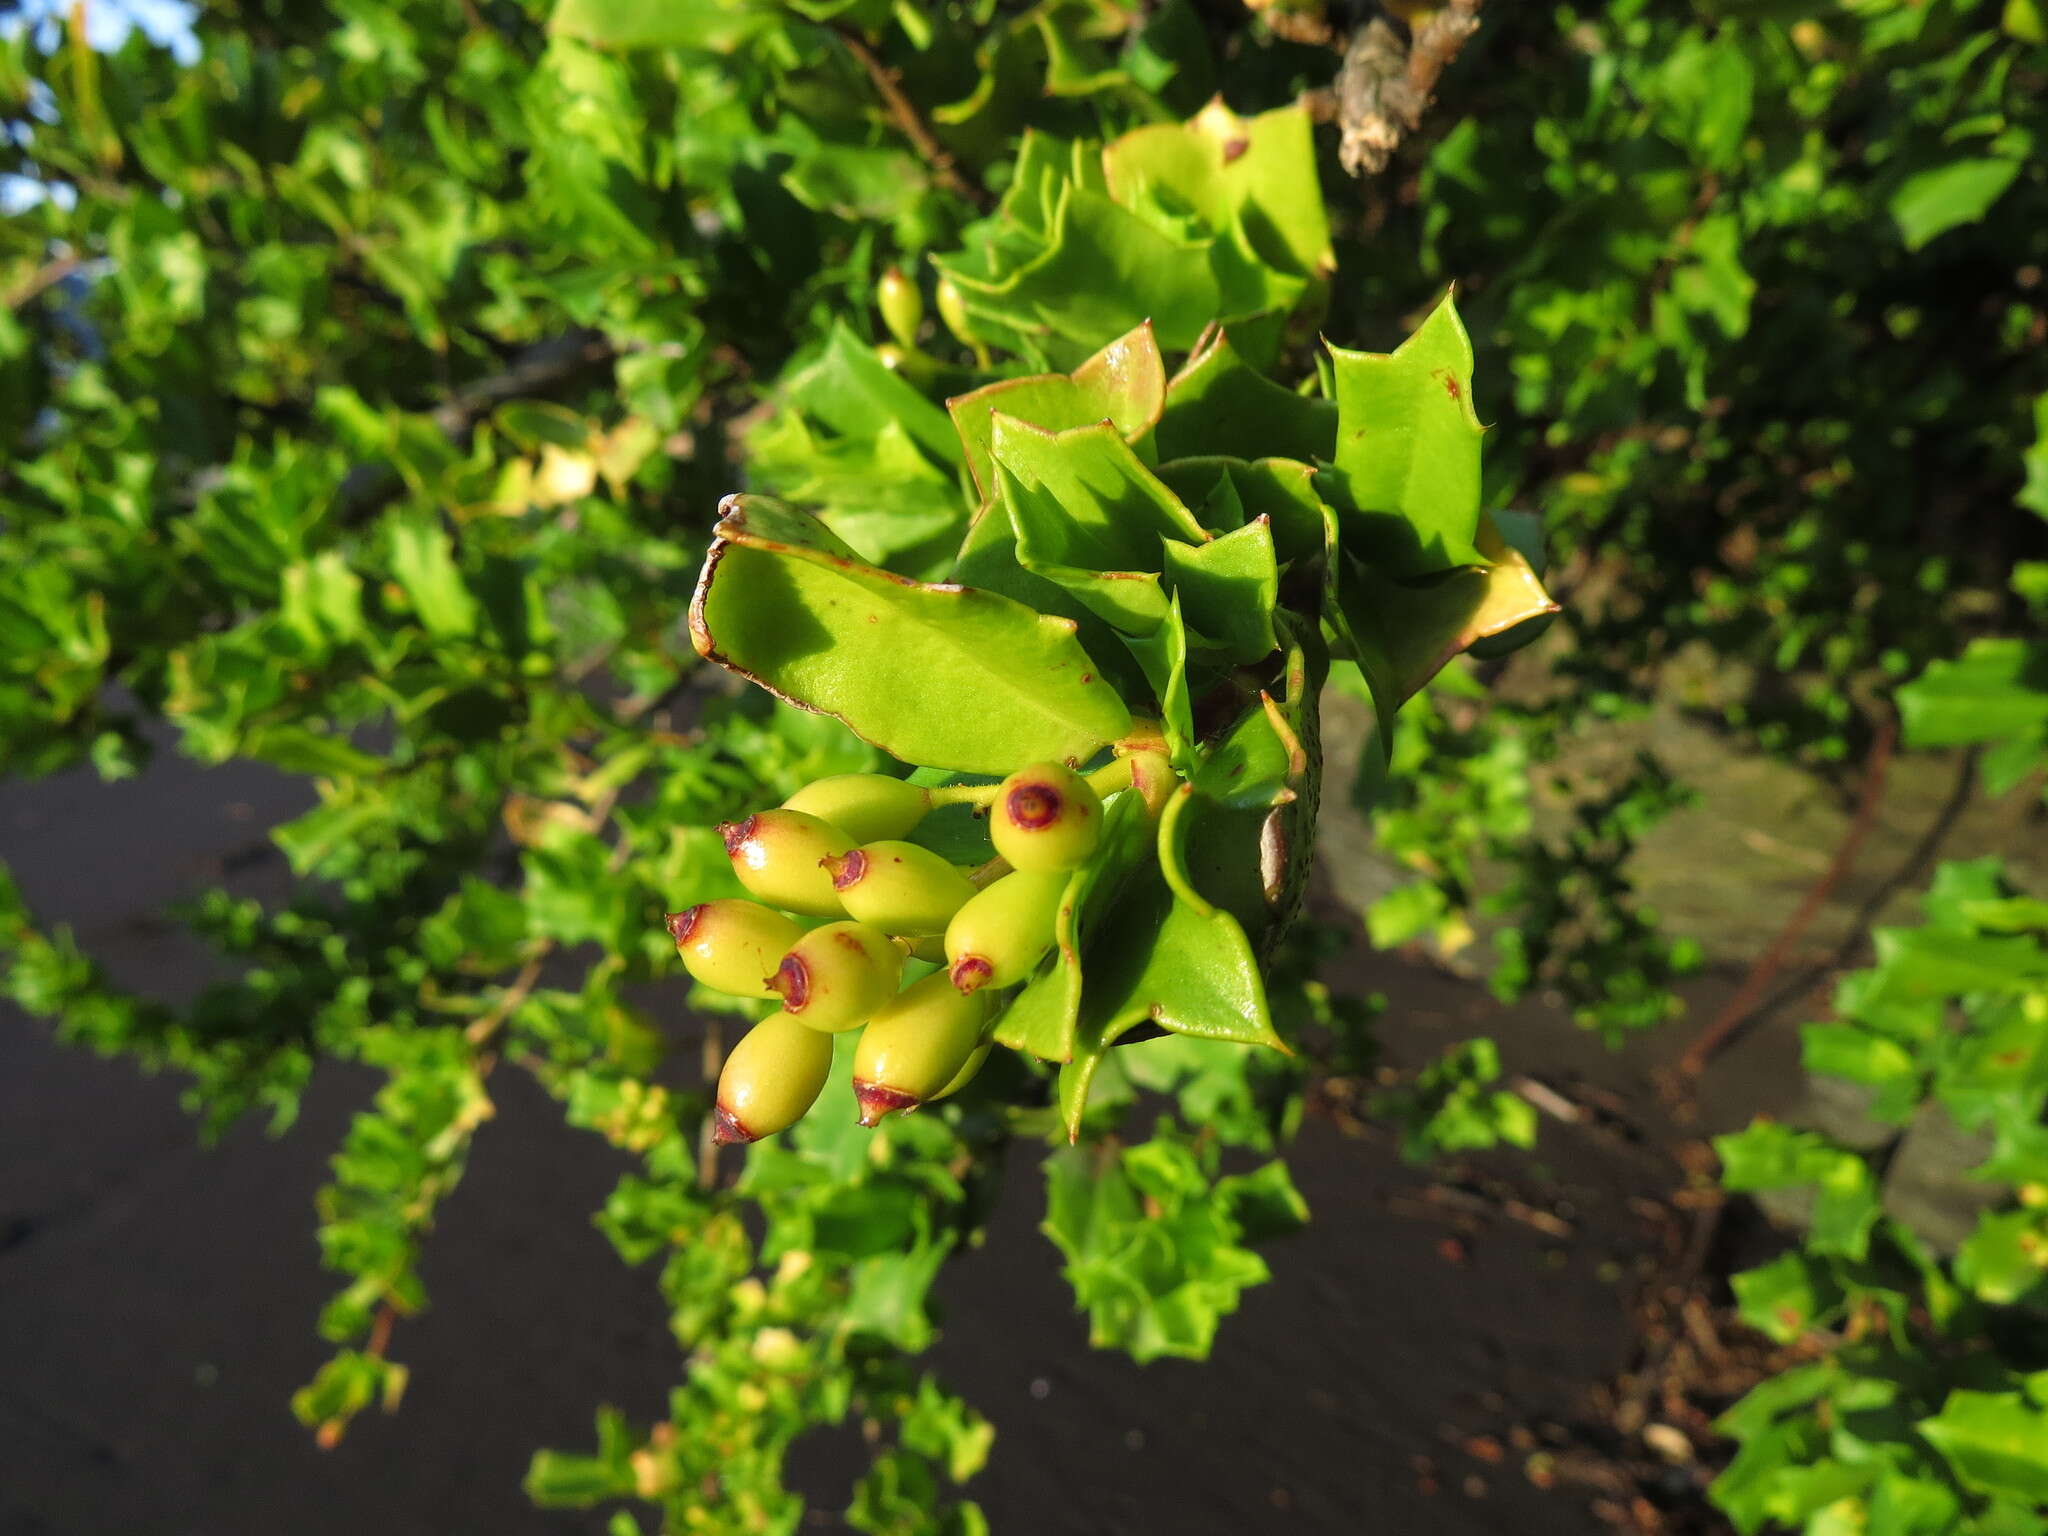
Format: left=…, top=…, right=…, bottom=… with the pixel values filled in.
left=0, top=754, right=1796, bottom=1536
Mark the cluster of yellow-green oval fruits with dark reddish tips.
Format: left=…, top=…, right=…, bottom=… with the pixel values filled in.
left=668, top=760, right=1130, bottom=1143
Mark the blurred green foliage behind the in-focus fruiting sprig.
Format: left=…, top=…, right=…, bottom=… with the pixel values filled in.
left=0, top=0, right=2048, bottom=1534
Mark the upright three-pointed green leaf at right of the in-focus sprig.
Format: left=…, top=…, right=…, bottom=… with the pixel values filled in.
left=1323, top=295, right=1487, bottom=578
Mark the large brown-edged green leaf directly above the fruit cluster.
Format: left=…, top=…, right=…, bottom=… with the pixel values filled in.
left=690, top=496, right=1130, bottom=772
